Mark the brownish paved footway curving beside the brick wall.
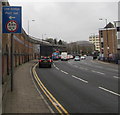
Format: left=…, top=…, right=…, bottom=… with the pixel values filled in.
left=4, top=61, right=52, bottom=113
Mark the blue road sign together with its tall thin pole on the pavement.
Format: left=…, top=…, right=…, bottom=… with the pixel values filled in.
left=2, top=6, right=22, bottom=91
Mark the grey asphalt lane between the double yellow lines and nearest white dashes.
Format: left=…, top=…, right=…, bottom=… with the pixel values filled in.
left=36, top=62, right=118, bottom=113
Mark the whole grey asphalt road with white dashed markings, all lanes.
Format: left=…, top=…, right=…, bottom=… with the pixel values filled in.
left=36, top=57, right=120, bottom=113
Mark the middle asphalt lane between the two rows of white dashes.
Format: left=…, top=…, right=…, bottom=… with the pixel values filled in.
left=55, top=62, right=118, bottom=92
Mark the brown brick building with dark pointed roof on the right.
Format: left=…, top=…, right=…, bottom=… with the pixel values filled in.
left=99, top=22, right=117, bottom=60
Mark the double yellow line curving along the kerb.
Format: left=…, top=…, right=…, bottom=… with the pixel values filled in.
left=32, top=63, right=69, bottom=115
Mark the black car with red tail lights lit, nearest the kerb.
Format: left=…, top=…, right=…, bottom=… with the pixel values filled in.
left=39, top=56, right=53, bottom=68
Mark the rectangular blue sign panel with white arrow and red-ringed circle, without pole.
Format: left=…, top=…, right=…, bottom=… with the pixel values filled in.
left=2, top=6, right=22, bottom=33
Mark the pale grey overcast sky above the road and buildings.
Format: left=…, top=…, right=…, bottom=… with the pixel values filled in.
left=9, top=0, right=118, bottom=42
